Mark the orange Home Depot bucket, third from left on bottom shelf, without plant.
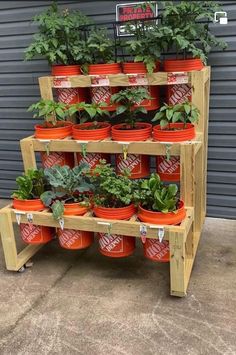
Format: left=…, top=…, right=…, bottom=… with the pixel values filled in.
left=93, top=205, right=135, bottom=258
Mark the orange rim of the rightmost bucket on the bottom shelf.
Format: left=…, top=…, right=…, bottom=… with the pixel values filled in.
left=138, top=201, right=186, bottom=225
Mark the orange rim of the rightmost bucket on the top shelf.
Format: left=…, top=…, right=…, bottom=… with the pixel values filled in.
left=164, top=58, right=204, bottom=72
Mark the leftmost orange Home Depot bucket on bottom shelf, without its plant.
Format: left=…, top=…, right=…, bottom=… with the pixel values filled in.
left=13, top=199, right=54, bottom=244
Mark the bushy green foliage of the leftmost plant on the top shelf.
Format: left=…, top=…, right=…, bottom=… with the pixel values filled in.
left=25, top=2, right=90, bottom=65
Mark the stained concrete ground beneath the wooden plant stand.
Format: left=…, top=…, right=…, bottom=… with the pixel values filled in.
left=0, top=202, right=236, bottom=355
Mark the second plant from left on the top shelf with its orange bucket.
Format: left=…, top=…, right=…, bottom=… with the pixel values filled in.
left=86, top=28, right=122, bottom=111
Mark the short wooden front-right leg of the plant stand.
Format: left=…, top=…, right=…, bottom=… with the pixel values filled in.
left=169, top=232, right=186, bottom=297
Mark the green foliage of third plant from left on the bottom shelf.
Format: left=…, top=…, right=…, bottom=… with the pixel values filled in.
left=91, top=160, right=133, bottom=208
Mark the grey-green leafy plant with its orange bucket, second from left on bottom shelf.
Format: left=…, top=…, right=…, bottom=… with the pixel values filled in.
left=40, top=164, right=93, bottom=249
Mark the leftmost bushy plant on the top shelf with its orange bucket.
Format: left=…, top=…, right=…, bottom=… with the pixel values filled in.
left=25, top=2, right=90, bottom=104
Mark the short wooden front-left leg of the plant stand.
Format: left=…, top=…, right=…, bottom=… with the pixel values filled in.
left=0, top=208, right=17, bottom=270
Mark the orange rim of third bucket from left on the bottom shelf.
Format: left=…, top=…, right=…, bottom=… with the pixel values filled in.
left=93, top=204, right=136, bottom=219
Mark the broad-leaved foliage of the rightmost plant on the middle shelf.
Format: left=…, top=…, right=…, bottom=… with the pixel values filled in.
left=152, top=101, right=200, bottom=129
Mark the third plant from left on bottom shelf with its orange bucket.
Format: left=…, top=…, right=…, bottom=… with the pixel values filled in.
left=91, top=161, right=136, bottom=258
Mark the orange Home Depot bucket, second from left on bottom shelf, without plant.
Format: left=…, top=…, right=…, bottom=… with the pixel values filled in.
left=57, top=202, right=94, bottom=250
